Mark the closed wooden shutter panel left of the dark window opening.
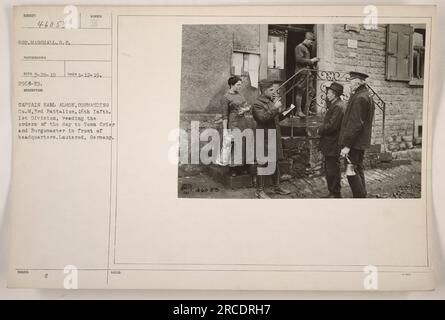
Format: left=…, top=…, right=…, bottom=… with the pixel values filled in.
left=386, top=24, right=413, bottom=81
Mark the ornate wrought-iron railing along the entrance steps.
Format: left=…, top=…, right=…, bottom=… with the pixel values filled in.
left=279, top=68, right=386, bottom=151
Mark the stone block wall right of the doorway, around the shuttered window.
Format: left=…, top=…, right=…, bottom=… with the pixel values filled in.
left=332, top=24, right=423, bottom=151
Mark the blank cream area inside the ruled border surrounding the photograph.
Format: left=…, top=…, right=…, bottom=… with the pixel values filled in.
left=115, top=16, right=428, bottom=269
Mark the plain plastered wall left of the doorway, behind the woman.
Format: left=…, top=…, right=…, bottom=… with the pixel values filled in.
left=181, top=25, right=260, bottom=114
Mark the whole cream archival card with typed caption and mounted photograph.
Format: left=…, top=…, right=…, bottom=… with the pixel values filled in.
left=9, top=6, right=436, bottom=290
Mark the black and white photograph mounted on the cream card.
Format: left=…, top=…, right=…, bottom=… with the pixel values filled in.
left=178, top=24, right=428, bottom=199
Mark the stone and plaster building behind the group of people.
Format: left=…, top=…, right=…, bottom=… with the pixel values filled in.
left=181, top=24, right=426, bottom=180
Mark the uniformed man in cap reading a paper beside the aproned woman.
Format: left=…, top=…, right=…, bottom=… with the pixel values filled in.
left=252, top=80, right=290, bottom=199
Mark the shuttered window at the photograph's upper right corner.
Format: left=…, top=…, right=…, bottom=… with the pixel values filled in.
left=386, top=24, right=425, bottom=85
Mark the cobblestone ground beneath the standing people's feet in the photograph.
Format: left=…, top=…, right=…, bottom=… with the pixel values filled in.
left=178, top=161, right=421, bottom=199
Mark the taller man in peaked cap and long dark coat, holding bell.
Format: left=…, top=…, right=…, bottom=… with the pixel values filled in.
left=339, top=71, right=375, bottom=198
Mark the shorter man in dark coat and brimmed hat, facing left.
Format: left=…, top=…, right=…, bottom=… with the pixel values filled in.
left=318, top=82, right=345, bottom=198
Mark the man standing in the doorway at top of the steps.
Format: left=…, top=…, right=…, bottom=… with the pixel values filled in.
left=294, top=32, right=320, bottom=117
